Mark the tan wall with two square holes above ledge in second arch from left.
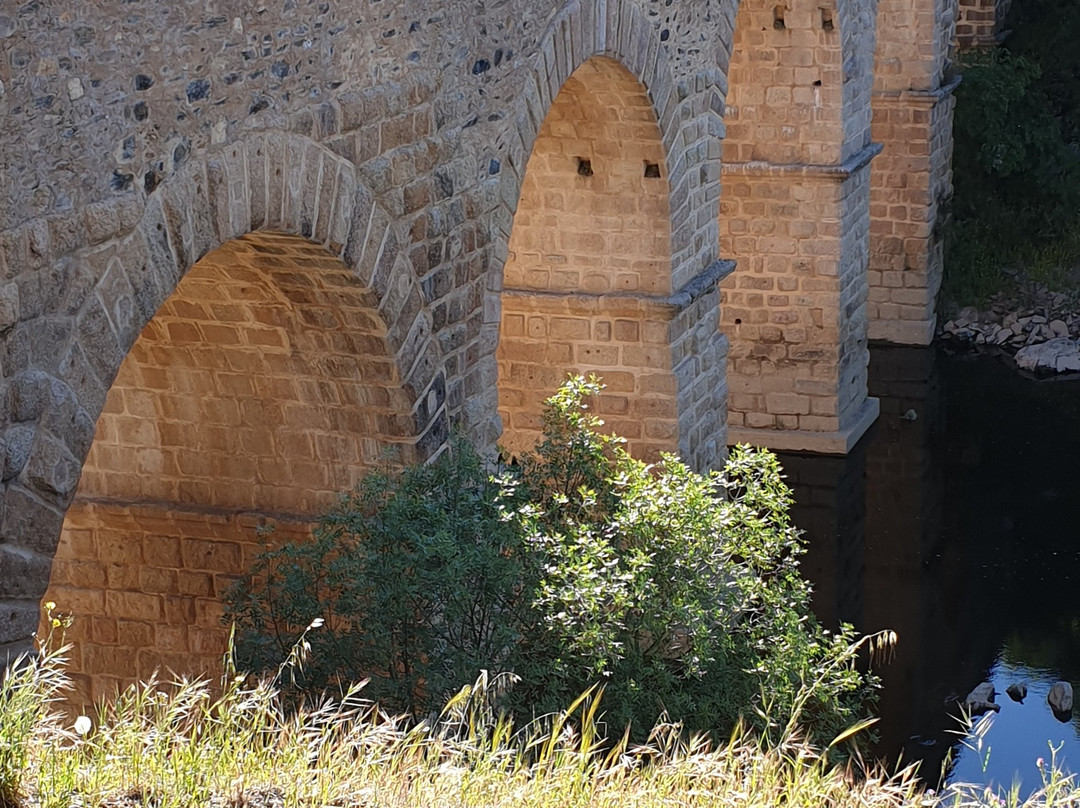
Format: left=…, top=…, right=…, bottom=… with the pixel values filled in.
left=503, top=58, right=671, bottom=295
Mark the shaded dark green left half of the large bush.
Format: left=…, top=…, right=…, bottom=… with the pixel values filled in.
left=226, top=442, right=521, bottom=715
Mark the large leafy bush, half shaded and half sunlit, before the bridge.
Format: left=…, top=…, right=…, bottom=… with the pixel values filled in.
left=228, top=378, right=873, bottom=741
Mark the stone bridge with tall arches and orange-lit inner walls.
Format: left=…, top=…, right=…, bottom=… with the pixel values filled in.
left=0, top=0, right=1000, bottom=699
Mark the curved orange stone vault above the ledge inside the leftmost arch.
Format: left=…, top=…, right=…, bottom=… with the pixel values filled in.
left=79, top=233, right=416, bottom=514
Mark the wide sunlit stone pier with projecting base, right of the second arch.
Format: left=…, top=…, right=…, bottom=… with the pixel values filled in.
left=720, top=0, right=879, bottom=453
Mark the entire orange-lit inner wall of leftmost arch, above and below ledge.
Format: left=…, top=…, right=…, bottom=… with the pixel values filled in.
left=43, top=233, right=425, bottom=704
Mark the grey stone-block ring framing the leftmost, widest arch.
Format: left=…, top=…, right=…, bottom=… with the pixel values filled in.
left=0, top=134, right=448, bottom=669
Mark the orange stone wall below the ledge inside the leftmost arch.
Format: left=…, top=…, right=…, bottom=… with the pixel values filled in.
left=42, top=499, right=310, bottom=708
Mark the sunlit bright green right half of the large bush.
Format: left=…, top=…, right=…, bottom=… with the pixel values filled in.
left=501, top=378, right=870, bottom=737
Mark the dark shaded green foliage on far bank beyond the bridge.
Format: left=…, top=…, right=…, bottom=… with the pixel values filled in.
left=945, top=14, right=1080, bottom=304
